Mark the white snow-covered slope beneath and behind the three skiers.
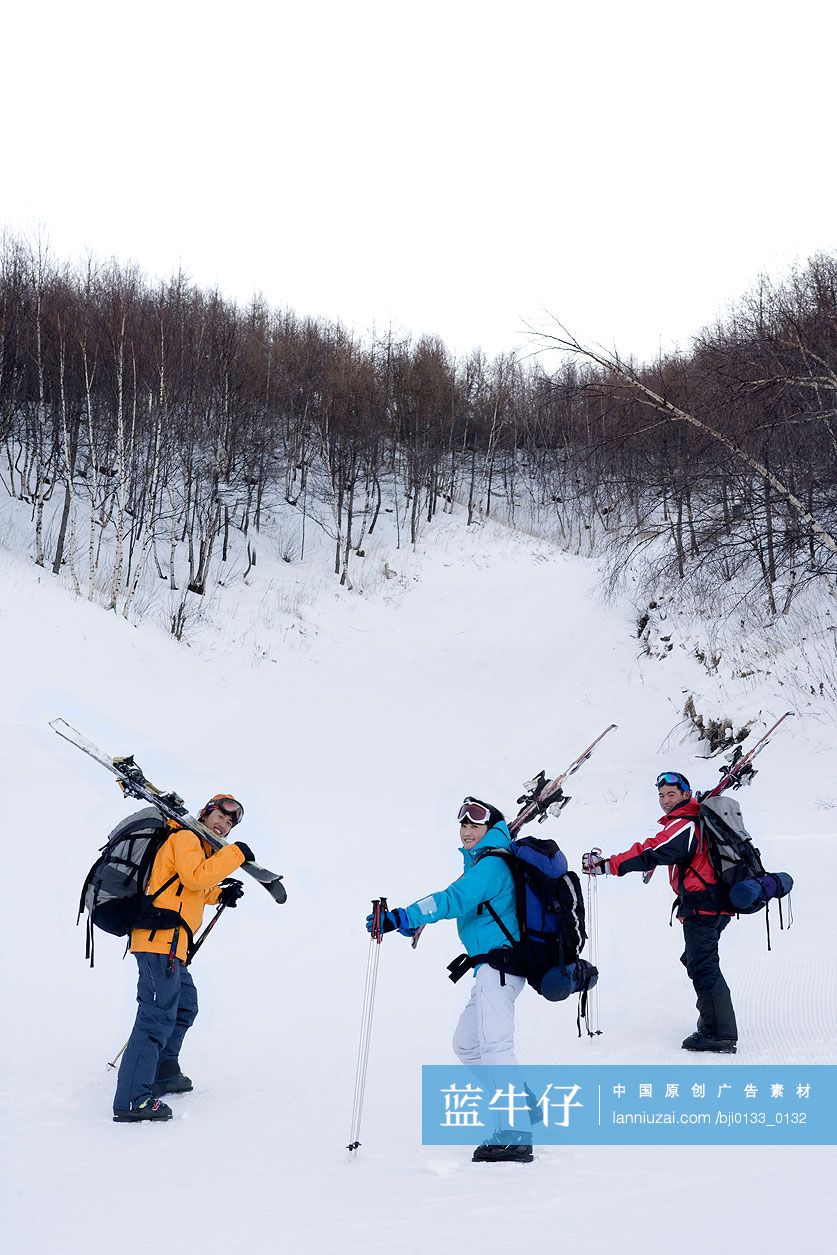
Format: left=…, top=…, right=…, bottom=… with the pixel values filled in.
left=0, top=504, right=837, bottom=1255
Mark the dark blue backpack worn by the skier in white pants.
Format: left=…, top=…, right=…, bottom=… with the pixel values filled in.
left=448, top=837, right=599, bottom=1032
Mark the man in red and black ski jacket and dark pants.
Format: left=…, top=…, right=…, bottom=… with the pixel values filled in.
left=581, top=772, right=738, bottom=1054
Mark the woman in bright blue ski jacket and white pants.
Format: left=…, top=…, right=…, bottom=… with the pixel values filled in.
left=366, top=797, right=532, bottom=1162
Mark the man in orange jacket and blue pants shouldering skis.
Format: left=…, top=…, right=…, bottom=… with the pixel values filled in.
left=113, top=793, right=255, bottom=1123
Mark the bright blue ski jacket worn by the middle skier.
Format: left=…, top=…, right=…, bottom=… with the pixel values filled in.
left=405, top=821, right=520, bottom=956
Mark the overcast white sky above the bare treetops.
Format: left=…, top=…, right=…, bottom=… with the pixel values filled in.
left=0, top=0, right=837, bottom=356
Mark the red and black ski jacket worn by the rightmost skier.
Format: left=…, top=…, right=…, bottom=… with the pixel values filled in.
left=609, top=797, right=729, bottom=919
